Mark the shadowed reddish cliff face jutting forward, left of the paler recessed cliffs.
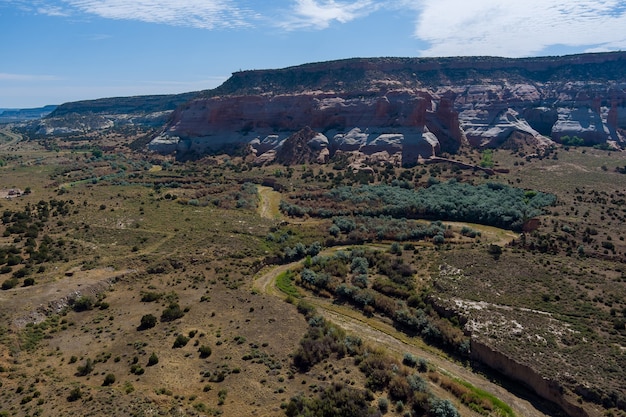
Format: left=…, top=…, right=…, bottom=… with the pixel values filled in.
left=148, top=90, right=448, bottom=163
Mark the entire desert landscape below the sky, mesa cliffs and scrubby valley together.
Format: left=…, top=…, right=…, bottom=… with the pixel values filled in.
left=0, top=52, right=626, bottom=417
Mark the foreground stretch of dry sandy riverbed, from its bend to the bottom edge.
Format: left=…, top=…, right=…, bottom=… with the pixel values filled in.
left=252, top=256, right=548, bottom=417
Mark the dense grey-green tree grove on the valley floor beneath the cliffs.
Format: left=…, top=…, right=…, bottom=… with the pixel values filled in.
left=280, top=179, right=556, bottom=229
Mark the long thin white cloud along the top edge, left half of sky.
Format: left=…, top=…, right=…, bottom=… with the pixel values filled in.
left=64, top=0, right=257, bottom=29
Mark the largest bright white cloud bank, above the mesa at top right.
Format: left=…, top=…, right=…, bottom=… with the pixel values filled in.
left=412, top=0, right=626, bottom=57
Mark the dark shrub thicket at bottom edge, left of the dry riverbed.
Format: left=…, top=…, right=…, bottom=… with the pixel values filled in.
left=285, top=301, right=459, bottom=417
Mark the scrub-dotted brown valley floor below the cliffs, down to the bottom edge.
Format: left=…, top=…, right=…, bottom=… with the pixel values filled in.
left=0, top=127, right=626, bottom=416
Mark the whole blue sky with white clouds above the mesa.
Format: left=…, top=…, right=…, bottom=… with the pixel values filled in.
left=0, top=0, right=626, bottom=108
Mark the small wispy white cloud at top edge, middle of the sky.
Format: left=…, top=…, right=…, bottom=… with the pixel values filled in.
left=279, top=0, right=380, bottom=30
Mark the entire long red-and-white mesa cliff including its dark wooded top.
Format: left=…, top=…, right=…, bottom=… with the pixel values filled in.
left=149, top=52, right=626, bottom=164
